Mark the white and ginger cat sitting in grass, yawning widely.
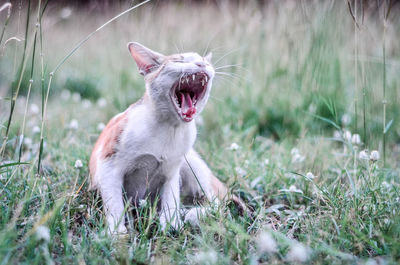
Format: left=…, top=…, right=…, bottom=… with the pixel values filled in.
left=89, top=42, right=245, bottom=233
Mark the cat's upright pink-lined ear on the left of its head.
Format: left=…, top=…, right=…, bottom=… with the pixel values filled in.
left=128, top=42, right=164, bottom=75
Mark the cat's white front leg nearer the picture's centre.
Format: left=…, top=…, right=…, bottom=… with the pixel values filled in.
left=160, top=167, right=182, bottom=230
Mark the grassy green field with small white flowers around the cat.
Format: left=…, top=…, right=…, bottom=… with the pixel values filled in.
left=0, top=1, right=400, bottom=264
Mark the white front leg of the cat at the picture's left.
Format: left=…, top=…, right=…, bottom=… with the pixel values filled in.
left=99, top=163, right=127, bottom=234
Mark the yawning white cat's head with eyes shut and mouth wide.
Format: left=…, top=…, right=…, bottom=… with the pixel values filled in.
left=128, top=42, right=215, bottom=122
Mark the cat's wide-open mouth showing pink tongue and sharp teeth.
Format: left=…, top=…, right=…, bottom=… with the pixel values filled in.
left=171, top=72, right=209, bottom=122
